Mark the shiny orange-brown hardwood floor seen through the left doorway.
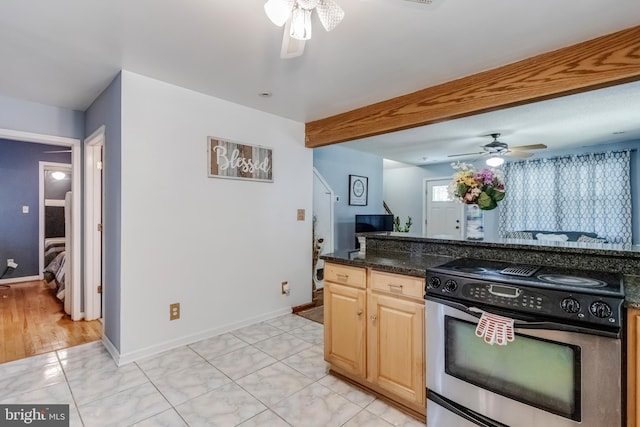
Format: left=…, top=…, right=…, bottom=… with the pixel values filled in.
left=0, top=280, right=102, bottom=363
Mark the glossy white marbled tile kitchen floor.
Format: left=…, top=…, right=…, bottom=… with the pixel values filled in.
left=0, top=315, right=424, bottom=427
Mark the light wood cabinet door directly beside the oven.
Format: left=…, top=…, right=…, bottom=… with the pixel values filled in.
left=367, top=292, right=426, bottom=407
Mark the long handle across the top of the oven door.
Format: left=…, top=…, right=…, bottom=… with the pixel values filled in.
left=427, top=296, right=620, bottom=338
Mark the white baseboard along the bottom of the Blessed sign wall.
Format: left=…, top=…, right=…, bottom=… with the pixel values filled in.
left=112, top=308, right=290, bottom=366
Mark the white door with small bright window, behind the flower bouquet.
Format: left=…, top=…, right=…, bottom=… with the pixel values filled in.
left=425, top=179, right=464, bottom=239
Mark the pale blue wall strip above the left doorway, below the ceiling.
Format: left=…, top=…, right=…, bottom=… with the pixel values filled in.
left=0, top=96, right=84, bottom=139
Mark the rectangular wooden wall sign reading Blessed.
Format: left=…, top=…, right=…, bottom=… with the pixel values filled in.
left=208, top=136, right=273, bottom=182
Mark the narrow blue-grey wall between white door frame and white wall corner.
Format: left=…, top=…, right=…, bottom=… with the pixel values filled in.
left=86, top=74, right=122, bottom=350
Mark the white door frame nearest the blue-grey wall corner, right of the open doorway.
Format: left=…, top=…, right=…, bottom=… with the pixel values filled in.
left=84, top=125, right=105, bottom=320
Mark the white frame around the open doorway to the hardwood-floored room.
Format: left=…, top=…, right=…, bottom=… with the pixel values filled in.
left=0, top=128, right=82, bottom=310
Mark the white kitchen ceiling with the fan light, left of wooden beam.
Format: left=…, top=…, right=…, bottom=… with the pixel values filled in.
left=0, top=0, right=640, bottom=129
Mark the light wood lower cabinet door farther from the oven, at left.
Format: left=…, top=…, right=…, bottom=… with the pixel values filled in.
left=324, top=282, right=366, bottom=378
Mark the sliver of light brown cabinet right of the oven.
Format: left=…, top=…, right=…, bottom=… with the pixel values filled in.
left=627, top=309, right=640, bottom=427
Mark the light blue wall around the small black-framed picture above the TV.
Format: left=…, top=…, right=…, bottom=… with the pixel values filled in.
left=313, top=145, right=386, bottom=250
